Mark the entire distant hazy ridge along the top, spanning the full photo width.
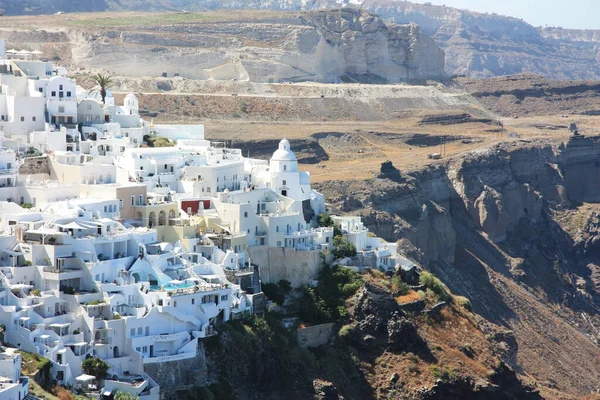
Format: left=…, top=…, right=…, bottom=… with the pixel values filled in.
left=0, top=0, right=600, bottom=79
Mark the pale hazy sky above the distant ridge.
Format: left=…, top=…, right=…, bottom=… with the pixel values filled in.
left=413, top=0, right=600, bottom=29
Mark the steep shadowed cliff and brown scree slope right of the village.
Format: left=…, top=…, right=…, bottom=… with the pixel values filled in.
left=320, top=137, right=600, bottom=398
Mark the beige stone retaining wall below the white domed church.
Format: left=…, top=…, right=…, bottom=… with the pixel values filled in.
left=247, top=246, right=323, bottom=287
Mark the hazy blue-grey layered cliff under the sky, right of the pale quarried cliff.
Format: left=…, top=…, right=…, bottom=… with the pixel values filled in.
left=354, top=0, right=600, bottom=79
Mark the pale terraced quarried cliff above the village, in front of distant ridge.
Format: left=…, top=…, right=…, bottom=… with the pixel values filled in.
left=2, top=8, right=444, bottom=82
